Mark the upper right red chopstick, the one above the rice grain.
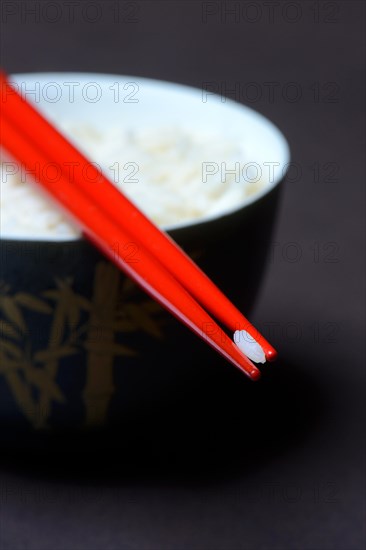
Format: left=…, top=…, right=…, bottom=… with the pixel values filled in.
left=0, top=73, right=277, bottom=361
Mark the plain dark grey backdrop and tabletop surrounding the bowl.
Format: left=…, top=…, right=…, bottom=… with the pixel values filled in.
left=0, top=0, right=365, bottom=550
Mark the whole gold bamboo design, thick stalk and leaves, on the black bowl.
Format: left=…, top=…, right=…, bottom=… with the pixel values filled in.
left=0, top=256, right=163, bottom=428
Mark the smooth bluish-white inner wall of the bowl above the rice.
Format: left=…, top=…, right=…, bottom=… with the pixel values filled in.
left=2, top=73, right=290, bottom=240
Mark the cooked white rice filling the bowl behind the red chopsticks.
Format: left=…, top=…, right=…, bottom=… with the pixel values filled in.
left=0, top=125, right=264, bottom=238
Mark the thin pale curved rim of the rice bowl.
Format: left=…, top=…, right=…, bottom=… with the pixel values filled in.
left=0, top=71, right=291, bottom=244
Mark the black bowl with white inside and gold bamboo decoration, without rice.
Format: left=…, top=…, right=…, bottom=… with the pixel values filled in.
left=0, top=73, right=289, bottom=433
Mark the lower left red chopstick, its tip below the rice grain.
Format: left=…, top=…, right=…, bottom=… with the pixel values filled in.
left=0, top=112, right=260, bottom=380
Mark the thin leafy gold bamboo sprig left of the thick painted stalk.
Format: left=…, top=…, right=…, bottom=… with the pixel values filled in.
left=0, top=280, right=81, bottom=428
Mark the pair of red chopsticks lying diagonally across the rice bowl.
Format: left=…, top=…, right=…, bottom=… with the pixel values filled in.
left=1, top=75, right=274, bottom=378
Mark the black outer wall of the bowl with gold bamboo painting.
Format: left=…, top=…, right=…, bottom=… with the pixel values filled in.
left=0, top=186, right=279, bottom=431
